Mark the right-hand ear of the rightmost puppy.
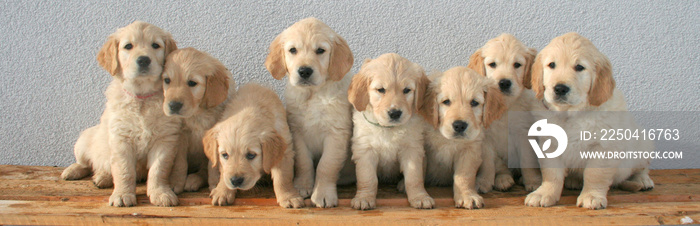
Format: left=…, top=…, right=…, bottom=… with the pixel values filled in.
left=588, top=54, right=615, bottom=106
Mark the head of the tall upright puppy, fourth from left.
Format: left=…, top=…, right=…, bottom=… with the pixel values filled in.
left=265, top=18, right=353, bottom=86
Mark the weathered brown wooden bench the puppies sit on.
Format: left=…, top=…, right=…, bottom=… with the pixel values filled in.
left=0, top=165, right=700, bottom=225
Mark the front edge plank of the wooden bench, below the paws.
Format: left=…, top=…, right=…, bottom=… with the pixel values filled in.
left=0, top=201, right=700, bottom=225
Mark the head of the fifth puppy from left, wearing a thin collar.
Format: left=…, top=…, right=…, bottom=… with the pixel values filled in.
left=348, top=53, right=432, bottom=126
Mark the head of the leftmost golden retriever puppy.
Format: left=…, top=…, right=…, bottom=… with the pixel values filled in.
left=97, top=21, right=177, bottom=84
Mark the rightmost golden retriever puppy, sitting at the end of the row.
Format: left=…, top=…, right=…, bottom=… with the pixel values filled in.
left=525, top=32, right=654, bottom=209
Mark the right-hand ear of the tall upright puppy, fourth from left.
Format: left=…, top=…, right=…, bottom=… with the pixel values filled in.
left=328, top=34, right=355, bottom=81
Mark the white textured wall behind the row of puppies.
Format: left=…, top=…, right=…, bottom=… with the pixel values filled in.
left=0, top=0, right=700, bottom=166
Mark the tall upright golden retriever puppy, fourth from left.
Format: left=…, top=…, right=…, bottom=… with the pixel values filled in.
left=265, top=18, right=354, bottom=208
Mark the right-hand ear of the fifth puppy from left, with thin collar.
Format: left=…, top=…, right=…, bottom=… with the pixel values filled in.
left=415, top=73, right=438, bottom=128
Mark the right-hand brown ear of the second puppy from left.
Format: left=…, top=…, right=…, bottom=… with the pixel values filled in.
left=200, top=64, right=231, bottom=109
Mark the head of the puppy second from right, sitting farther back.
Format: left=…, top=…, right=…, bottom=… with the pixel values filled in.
left=467, top=34, right=537, bottom=99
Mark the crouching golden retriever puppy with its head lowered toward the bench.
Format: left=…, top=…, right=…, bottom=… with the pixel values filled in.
left=203, top=84, right=304, bottom=208
